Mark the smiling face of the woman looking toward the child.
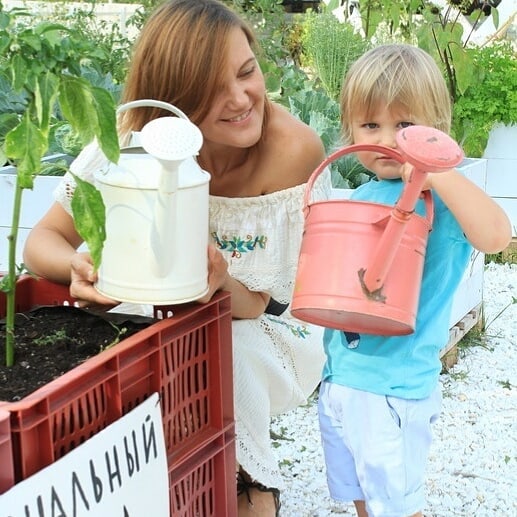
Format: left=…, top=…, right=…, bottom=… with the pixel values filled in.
left=199, top=28, right=266, bottom=148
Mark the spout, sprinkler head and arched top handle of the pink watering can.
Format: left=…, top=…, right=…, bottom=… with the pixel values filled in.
left=303, top=126, right=464, bottom=294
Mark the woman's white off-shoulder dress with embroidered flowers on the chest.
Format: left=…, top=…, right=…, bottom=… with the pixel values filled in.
left=54, top=140, right=330, bottom=488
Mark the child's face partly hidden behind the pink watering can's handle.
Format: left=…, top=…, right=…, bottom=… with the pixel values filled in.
left=351, top=105, right=422, bottom=179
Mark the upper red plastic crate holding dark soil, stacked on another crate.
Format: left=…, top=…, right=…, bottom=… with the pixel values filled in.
left=0, top=276, right=235, bottom=512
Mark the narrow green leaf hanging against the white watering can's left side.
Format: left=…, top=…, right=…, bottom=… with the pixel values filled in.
left=72, top=174, right=106, bottom=269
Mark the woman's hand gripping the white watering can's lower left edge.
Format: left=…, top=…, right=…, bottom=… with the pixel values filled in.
left=70, top=252, right=119, bottom=310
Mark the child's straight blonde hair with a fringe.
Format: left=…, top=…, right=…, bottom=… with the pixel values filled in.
left=340, top=44, right=451, bottom=144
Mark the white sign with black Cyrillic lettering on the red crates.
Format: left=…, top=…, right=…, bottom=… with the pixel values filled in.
left=0, top=393, right=169, bottom=517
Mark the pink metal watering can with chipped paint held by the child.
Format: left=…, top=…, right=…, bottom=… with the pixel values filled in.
left=291, top=126, right=463, bottom=335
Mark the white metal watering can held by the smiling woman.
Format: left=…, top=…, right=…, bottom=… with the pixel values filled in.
left=95, top=99, right=210, bottom=305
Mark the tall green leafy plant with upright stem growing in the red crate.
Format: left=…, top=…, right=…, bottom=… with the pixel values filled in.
left=0, top=3, right=119, bottom=366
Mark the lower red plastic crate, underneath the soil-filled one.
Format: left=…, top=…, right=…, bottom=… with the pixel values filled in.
left=169, top=425, right=237, bottom=517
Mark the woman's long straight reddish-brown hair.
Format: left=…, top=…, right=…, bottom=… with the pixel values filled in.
left=119, top=0, right=269, bottom=133
